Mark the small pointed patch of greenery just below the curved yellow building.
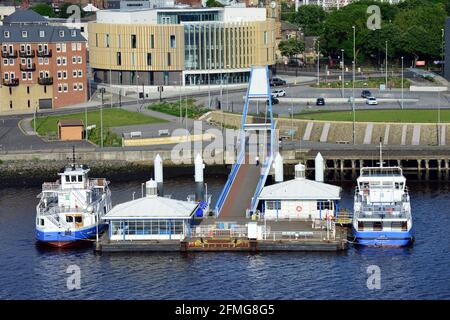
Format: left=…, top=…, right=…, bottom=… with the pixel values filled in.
left=147, top=99, right=209, bottom=119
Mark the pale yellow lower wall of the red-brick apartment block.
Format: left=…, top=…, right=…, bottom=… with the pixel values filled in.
left=0, top=82, right=53, bottom=114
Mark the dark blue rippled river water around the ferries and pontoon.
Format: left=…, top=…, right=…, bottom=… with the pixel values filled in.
left=0, top=176, right=450, bottom=299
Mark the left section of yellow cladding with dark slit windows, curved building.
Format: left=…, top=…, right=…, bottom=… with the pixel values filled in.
left=89, top=22, right=184, bottom=71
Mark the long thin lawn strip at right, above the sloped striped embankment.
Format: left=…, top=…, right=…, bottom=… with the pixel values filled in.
left=295, top=109, right=450, bottom=123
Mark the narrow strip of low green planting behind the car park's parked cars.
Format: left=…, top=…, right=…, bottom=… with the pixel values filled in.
left=313, top=77, right=411, bottom=89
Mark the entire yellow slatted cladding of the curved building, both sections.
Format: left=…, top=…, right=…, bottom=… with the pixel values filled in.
left=89, top=19, right=276, bottom=71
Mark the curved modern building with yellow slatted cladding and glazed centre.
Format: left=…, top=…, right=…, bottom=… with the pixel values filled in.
left=89, top=7, right=276, bottom=86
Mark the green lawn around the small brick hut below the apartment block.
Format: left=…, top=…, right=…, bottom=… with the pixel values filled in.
left=31, top=108, right=166, bottom=146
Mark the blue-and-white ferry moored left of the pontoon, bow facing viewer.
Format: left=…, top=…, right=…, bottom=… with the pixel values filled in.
left=36, top=156, right=112, bottom=247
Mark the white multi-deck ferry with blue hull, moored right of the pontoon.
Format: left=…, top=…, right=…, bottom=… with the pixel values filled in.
left=352, top=146, right=414, bottom=247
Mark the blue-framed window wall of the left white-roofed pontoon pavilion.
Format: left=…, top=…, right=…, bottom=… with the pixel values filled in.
left=110, top=219, right=184, bottom=239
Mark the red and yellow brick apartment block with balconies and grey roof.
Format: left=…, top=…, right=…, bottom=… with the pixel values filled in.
left=0, top=10, right=88, bottom=114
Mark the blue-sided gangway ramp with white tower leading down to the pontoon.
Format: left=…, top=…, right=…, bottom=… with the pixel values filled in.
left=215, top=66, right=275, bottom=218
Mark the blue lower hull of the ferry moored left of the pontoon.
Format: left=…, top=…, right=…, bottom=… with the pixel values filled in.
left=36, top=224, right=106, bottom=248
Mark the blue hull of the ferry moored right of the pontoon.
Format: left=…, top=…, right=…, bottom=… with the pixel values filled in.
left=353, top=229, right=414, bottom=247
